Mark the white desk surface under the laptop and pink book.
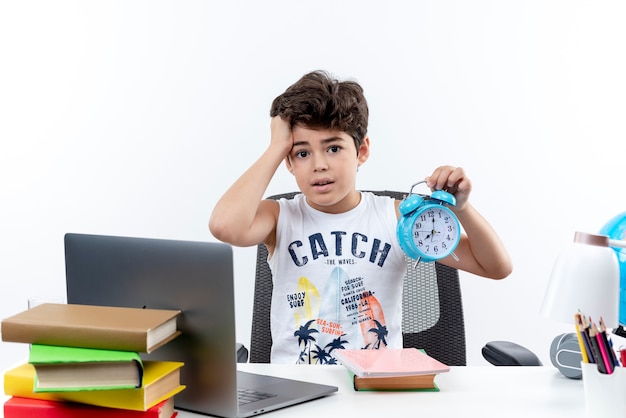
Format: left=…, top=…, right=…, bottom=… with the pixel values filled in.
left=173, top=364, right=585, bottom=418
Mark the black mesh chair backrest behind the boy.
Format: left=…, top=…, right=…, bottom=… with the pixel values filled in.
left=250, top=190, right=466, bottom=366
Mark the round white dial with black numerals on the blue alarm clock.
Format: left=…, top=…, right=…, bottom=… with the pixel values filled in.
left=411, top=206, right=459, bottom=259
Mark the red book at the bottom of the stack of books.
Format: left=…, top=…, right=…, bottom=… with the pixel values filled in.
left=4, top=396, right=178, bottom=418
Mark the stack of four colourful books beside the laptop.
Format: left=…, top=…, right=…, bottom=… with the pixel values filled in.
left=1, top=303, right=185, bottom=418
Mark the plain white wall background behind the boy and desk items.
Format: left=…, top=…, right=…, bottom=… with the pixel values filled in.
left=0, top=0, right=626, bottom=366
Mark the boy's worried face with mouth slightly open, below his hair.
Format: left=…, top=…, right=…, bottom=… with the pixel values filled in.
left=285, top=126, right=369, bottom=213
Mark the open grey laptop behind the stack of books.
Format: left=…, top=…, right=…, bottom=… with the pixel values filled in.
left=65, top=233, right=337, bottom=418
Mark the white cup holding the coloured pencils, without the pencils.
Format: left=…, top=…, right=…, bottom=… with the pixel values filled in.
left=581, top=362, right=626, bottom=418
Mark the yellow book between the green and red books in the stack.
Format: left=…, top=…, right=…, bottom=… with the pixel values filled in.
left=4, top=361, right=185, bottom=411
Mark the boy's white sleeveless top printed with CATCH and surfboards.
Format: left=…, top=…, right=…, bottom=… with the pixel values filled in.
left=268, top=192, right=406, bottom=364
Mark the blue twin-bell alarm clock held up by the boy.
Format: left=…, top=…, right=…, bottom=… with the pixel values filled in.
left=396, top=181, right=461, bottom=262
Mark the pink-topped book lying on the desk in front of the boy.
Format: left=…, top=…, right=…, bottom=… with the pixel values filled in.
left=333, top=348, right=450, bottom=391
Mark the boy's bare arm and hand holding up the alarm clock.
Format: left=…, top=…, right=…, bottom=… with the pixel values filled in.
left=427, top=166, right=513, bottom=279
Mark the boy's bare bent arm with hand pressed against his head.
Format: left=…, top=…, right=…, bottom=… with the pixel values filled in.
left=209, top=117, right=293, bottom=247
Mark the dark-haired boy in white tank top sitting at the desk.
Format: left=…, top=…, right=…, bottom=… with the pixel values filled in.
left=209, top=71, right=512, bottom=364
